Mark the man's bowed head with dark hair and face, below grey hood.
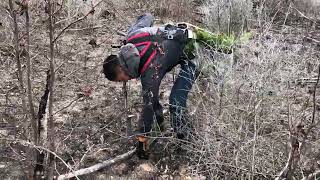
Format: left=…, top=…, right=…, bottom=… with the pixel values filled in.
left=103, top=55, right=131, bottom=81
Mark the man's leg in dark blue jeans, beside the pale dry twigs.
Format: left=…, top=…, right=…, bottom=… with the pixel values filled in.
left=169, top=61, right=198, bottom=139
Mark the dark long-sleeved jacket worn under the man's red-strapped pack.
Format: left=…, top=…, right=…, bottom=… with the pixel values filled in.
left=127, top=14, right=185, bottom=133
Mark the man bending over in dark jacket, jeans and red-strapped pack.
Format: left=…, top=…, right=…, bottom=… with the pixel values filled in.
left=103, top=13, right=225, bottom=159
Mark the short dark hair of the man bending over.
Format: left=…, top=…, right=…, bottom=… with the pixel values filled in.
left=103, top=55, right=120, bottom=81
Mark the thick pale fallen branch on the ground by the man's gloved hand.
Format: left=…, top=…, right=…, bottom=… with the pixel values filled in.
left=58, top=149, right=136, bottom=180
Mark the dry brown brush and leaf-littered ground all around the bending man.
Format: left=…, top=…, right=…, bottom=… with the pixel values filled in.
left=0, top=0, right=320, bottom=179
